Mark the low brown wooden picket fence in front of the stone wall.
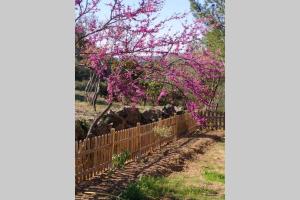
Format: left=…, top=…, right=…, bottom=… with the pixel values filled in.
left=75, top=111, right=225, bottom=183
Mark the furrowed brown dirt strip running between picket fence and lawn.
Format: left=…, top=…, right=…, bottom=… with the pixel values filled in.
left=75, top=131, right=224, bottom=200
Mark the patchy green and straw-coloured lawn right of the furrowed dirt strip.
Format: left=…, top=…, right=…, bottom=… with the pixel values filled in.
left=121, top=142, right=225, bottom=200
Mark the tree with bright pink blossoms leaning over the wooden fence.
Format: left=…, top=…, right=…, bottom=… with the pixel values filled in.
left=75, top=0, right=224, bottom=135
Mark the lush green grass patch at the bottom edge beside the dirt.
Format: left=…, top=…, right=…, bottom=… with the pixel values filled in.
left=121, top=176, right=217, bottom=200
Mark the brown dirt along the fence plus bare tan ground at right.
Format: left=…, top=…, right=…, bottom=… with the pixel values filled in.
left=75, top=131, right=224, bottom=200
